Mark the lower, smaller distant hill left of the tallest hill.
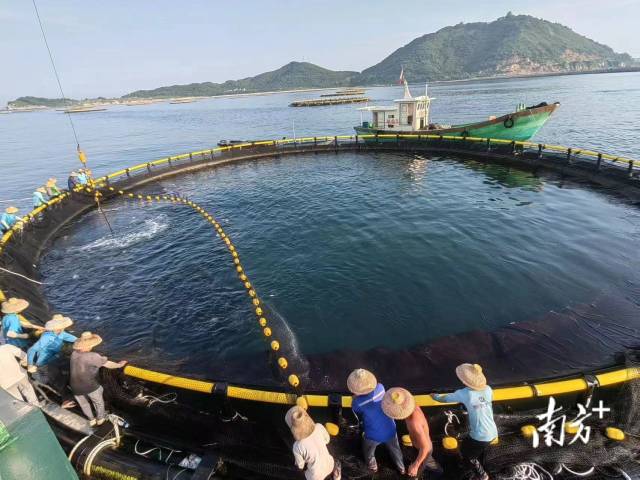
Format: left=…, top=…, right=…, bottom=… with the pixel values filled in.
left=123, top=62, right=358, bottom=98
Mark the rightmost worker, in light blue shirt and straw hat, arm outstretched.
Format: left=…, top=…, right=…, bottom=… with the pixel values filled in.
left=433, top=363, right=498, bottom=479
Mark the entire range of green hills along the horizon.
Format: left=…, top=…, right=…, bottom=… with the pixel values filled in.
left=9, top=13, right=640, bottom=108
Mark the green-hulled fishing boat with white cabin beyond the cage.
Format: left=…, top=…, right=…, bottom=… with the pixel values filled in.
left=354, top=73, right=560, bottom=141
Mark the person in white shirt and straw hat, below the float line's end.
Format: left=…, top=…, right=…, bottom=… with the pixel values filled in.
left=284, top=405, right=341, bottom=480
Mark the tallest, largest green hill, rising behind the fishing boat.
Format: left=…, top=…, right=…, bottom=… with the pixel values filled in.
left=357, top=13, right=633, bottom=84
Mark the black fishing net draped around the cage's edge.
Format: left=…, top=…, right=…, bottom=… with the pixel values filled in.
left=0, top=144, right=640, bottom=480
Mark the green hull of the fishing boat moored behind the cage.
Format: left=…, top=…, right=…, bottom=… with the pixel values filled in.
left=354, top=103, right=560, bottom=141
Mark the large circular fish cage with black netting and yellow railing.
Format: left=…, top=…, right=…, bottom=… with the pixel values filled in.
left=0, top=135, right=640, bottom=478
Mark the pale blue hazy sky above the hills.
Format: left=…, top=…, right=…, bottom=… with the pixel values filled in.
left=0, top=0, right=640, bottom=105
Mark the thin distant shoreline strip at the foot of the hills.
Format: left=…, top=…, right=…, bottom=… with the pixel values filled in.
left=6, top=66, right=640, bottom=113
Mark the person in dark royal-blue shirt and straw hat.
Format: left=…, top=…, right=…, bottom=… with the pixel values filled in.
left=347, top=368, right=405, bottom=475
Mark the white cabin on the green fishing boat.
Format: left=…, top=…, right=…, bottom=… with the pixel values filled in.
left=358, top=82, right=432, bottom=132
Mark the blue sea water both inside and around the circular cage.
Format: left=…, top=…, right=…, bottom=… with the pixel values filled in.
left=0, top=73, right=640, bottom=378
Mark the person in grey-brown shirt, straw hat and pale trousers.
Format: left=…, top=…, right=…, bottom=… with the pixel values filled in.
left=69, top=332, right=127, bottom=426
